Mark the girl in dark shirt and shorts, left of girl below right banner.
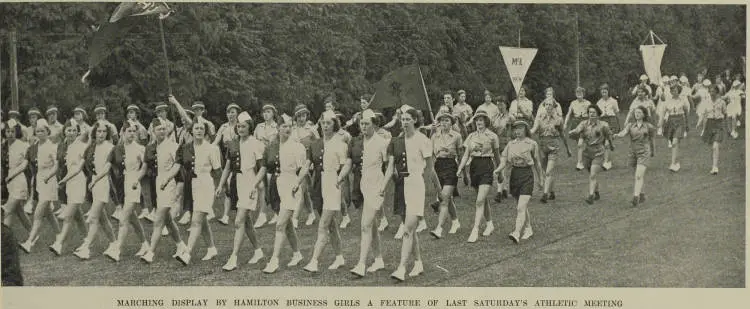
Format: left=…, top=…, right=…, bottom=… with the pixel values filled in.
left=568, top=104, right=613, bottom=204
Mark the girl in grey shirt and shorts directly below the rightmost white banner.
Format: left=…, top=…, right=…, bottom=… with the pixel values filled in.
left=614, top=106, right=656, bottom=207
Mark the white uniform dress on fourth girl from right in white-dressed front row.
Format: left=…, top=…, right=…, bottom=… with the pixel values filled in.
left=276, top=138, right=307, bottom=210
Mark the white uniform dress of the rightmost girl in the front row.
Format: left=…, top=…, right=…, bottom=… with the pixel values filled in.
left=404, top=132, right=432, bottom=217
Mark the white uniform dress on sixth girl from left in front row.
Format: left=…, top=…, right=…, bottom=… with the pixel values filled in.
left=156, top=138, right=180, bottom=208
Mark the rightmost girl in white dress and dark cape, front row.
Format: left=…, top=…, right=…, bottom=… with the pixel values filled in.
left=388, top=108, right=435, bottom=281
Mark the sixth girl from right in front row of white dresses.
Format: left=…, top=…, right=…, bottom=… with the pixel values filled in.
left=175, top=115, right=222, bottom=266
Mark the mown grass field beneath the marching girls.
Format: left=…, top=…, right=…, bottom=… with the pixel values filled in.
left=7, top=115, right=745, bottom=288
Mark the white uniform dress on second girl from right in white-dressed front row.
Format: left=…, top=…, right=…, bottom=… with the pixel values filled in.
left=360, top=134, right=389, bottom=210
